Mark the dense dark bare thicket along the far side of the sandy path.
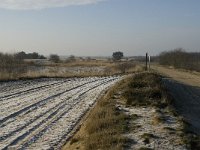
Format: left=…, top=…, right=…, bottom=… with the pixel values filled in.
left=158, top=48, right=200, bottom=71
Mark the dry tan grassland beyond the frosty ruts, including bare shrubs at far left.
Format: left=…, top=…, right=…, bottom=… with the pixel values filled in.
left=0, top=54, right=141, bottom=80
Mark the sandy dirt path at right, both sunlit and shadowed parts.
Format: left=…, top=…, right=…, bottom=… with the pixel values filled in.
left=153, top=66, right=200, bottom=135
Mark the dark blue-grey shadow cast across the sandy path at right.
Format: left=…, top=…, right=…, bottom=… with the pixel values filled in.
left=163, top=78, right=200, bottom=135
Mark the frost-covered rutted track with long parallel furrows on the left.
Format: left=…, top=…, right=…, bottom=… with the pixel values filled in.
left=0, top=76, right=121, bottom=150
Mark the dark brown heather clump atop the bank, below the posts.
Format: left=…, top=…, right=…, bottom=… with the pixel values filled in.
left=123, top=73, right=171, bottom=108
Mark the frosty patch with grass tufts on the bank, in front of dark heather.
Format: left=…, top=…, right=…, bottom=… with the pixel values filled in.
left=116, top=101, right=187, bottom=150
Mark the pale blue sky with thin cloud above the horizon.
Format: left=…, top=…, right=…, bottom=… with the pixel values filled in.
left=0, top=0, right=200, bottom=56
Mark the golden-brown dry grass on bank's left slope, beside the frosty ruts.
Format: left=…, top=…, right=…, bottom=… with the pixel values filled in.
left=85, top=82, right=128, bottom=150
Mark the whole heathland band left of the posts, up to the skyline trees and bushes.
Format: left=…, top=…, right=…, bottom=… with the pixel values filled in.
left=0, top=52, right=140, bottom=80
